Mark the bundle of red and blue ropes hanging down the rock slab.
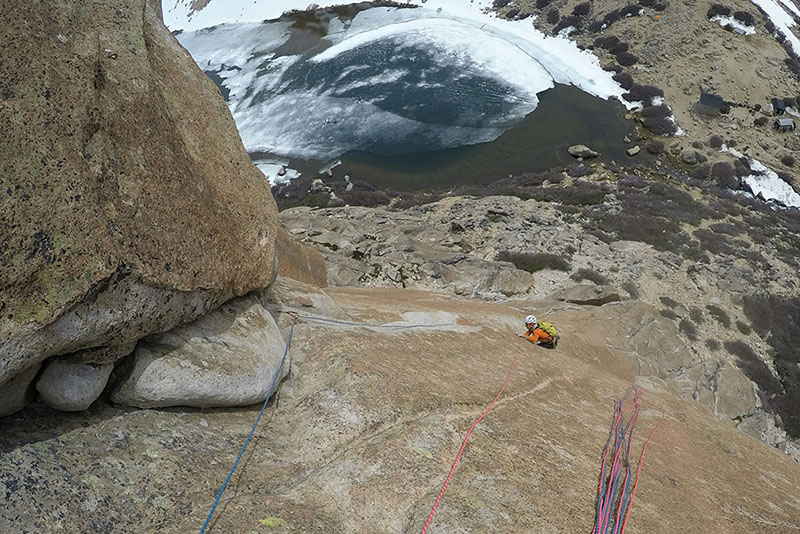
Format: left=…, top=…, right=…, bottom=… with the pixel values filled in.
left=592, top=386, right=664, bottom=534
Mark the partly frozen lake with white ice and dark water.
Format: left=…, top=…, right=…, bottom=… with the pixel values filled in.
left=177, top=4, right=629, bottom=188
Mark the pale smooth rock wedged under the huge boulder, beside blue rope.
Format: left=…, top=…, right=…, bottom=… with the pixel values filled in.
left=111, top=296, right=289, bottom=408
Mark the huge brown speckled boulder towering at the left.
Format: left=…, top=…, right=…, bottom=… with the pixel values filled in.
left=0, top=0, right=277, bottom=411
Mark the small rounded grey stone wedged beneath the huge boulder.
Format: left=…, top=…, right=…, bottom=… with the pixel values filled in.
left=36, top=358, right=114, bottom=412
